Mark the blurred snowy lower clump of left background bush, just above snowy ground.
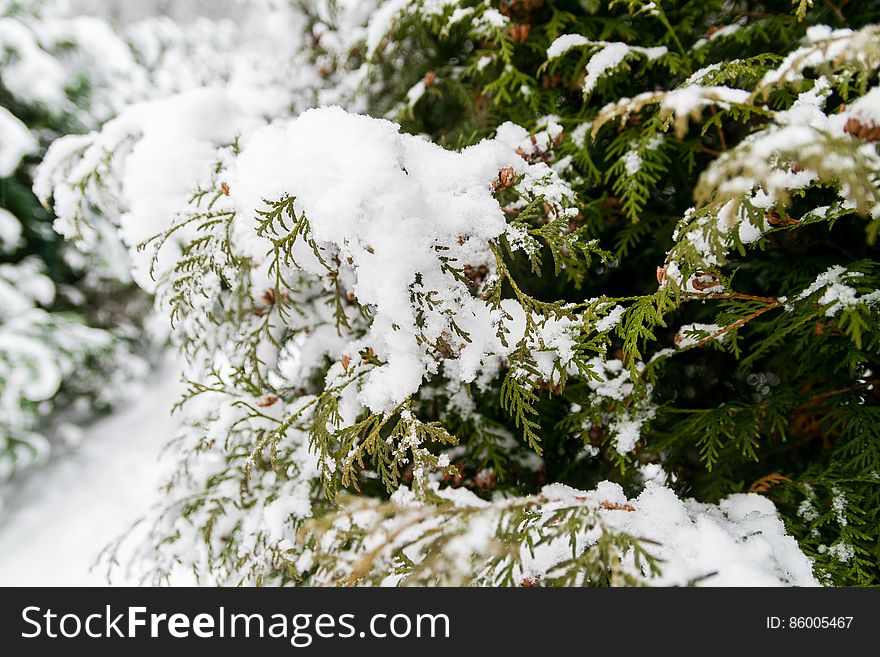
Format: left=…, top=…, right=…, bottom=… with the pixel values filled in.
left=0, top=251, right=146, bottom=479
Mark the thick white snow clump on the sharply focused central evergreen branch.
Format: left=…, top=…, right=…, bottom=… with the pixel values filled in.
left=229, top=107, right=558, bottom=412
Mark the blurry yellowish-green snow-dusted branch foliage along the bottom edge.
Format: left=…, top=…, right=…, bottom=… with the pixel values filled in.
left=300, top=496, right=659, bottom=586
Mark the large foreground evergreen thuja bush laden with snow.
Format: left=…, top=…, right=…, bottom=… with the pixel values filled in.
left=36, top=0, right=880, bottom=586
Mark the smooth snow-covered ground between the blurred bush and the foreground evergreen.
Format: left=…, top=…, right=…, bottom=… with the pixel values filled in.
left=0, top=359, right=181, bottom=586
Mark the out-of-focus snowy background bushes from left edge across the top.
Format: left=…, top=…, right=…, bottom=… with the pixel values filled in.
left=0, top=0, right=312, bottom=480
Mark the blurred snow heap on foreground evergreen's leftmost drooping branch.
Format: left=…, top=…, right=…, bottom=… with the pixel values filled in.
left=34, top=88, right=262, bottom=291
